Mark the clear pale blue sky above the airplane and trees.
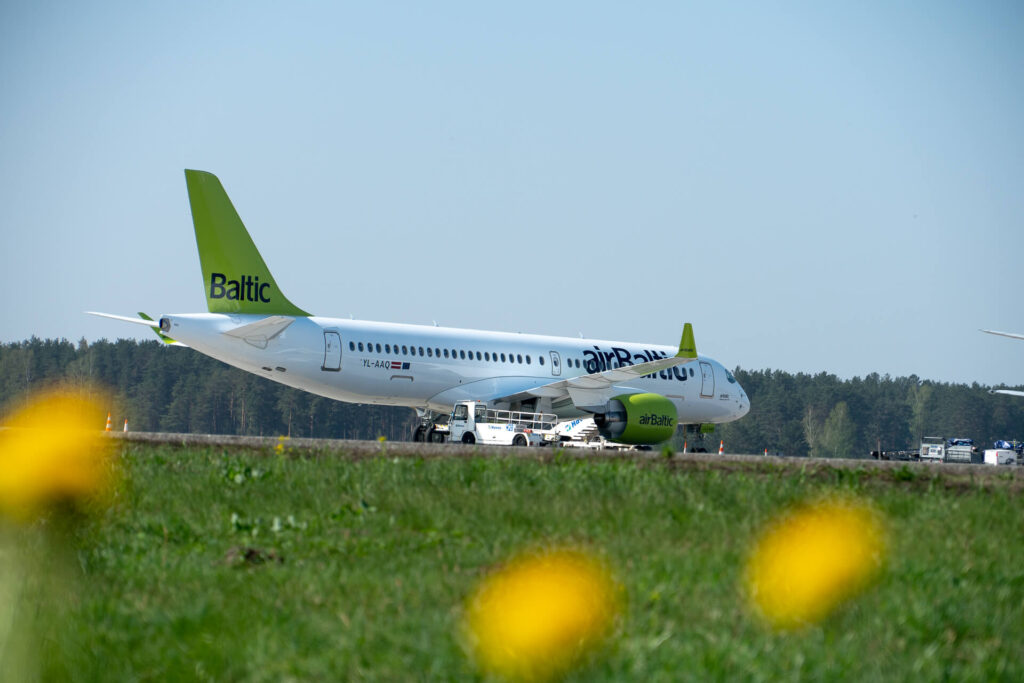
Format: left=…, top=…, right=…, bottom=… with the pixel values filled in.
left=0, top=2, right=1024, bottom=385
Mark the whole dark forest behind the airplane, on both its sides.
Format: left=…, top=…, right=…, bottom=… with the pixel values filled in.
left=0, top=337, right=1024, bottom=458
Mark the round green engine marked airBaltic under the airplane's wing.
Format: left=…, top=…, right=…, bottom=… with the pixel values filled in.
left=594, top=393, right=679, bottom=445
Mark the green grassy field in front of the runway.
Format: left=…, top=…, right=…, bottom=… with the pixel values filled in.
left=9, top=444, right=1024, bottom=681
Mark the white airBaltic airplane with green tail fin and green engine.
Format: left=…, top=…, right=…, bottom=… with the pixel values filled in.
left=87, top=170, right=750, bottom=445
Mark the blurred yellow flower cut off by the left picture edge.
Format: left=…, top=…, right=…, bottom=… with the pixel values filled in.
left=0, top=390, right=113, bottom=521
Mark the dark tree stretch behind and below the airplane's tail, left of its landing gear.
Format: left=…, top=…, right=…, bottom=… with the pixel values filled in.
left=0, top=337, right=417, bottom=440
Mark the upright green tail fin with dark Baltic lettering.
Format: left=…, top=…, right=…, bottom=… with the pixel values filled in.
left=185, top=170, right=309, bottom=315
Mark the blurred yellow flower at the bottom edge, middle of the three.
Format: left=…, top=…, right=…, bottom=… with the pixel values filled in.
left=464, top=549, right=621, bottom=680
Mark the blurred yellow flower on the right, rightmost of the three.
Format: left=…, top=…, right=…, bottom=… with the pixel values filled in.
left=746, top=500, right=885, bottom=629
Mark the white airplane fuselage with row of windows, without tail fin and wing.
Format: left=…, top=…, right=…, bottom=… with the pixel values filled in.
left=164, top=313, right=750, bottom=424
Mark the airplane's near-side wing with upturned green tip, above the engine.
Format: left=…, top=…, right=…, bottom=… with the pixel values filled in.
left=492, top=323, right=697, bottom=410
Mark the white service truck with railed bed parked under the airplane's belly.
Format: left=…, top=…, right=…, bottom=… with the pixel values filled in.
left=447, top=400, right=559, bottom=445
